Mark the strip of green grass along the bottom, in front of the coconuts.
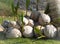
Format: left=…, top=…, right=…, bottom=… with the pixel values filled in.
left=0, top=32, right=60, bottom=44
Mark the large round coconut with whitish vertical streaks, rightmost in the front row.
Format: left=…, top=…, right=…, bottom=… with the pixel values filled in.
left=44, top=25, right=57, bottom=38
